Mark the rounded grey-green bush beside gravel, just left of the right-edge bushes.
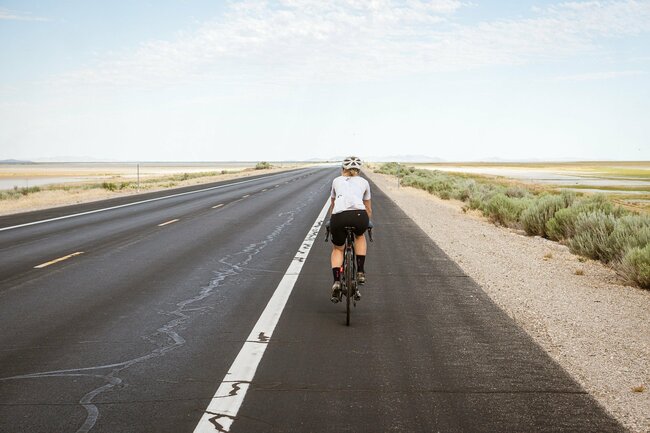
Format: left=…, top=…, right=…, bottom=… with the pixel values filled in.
left=569, top=211, right=616, bottom=261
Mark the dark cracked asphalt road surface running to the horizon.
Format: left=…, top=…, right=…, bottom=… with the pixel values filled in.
left=0, top=168, right=624, bottom=433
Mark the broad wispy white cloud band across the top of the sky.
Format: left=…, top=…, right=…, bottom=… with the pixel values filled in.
left=58, top=0, right=650, bottom=85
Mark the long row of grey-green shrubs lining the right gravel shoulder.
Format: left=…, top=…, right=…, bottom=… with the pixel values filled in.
left=375, top=163, right=650, bottom=289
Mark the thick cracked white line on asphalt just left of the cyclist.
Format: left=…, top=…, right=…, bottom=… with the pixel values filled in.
left=194, top=200, right=330, bottom=433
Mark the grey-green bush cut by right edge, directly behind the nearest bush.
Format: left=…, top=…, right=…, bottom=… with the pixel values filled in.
left=607, top=215, right=650, bottom=262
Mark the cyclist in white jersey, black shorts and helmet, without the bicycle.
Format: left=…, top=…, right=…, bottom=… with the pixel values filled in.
left=329, top=156, right=372, bottom=303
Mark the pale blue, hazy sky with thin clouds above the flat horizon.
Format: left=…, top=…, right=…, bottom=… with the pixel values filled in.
left=0, top=0, right=650, bottom=161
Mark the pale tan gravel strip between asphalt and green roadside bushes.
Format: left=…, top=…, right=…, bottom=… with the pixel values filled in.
left=364, top=172, right=650, bottom=433
